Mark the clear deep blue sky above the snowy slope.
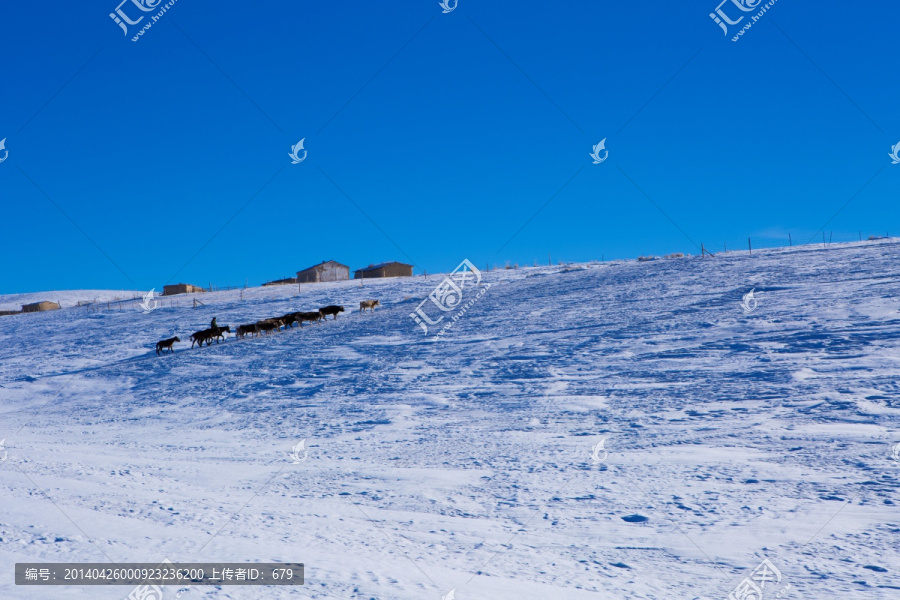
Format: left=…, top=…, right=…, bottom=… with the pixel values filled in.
left=0, top=0, right=900, bottom=293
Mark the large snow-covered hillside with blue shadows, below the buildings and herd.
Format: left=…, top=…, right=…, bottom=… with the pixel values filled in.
left=0, top=240, right=900, bottom=600
